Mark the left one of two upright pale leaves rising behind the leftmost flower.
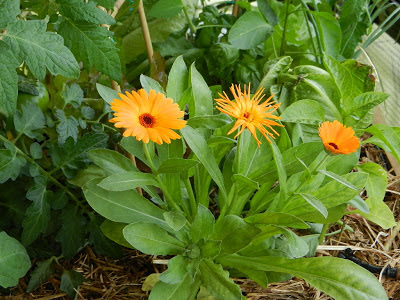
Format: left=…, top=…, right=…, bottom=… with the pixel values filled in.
left=167, top=56, right=189, bottom=103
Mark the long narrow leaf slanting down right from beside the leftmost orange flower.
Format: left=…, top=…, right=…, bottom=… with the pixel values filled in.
left=181, top=126, right=226, bottom=195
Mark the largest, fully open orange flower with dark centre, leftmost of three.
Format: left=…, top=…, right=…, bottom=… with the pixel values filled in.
left=110, top=89, right=186, bottom=145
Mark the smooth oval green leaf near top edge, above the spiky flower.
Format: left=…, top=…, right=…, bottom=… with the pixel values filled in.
left=228, top=11, right=273, bottom=50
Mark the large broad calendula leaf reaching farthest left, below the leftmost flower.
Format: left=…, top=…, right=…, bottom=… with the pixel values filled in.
left=83, top=179, right=169, bottom=228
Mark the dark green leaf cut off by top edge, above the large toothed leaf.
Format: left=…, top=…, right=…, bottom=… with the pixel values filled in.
left=56, top=0, right=115, bottom=25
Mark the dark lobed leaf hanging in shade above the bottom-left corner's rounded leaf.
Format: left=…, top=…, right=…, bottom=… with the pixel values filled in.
left=21, top=176, right=50, bottom=247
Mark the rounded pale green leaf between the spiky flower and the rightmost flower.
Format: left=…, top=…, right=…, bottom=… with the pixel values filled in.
left=281, top=100, right=325, bottom=125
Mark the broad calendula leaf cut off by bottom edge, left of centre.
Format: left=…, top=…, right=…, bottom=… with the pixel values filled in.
left=149, top=274, right=193, bottom=300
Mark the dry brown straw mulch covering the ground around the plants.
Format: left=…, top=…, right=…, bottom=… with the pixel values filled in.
left=0, top=145, right=400, bottom=300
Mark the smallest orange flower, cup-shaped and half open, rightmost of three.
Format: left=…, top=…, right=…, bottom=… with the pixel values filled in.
left=318, top=120, right=360, bottom=154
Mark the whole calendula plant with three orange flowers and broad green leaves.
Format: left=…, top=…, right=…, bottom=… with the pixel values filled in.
left=83, top=57, right=393, bottom=299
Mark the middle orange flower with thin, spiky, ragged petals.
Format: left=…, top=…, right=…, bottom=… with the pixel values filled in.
left=215, top=84, right=283, bottom=146
